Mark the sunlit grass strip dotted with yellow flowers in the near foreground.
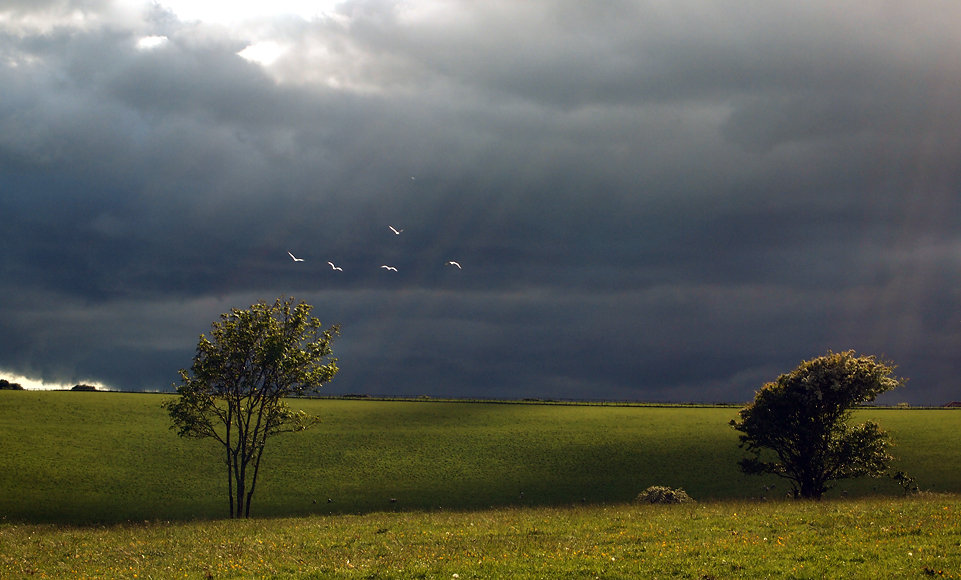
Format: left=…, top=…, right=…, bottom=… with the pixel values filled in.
left=0, top=494, right=961, bottom=580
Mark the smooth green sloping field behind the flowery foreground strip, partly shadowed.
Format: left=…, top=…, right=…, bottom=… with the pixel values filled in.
left=0, top=391, right=961, bottom=524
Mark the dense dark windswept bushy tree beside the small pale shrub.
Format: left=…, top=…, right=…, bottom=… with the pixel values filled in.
left=731, top=351, right=904, bottom=499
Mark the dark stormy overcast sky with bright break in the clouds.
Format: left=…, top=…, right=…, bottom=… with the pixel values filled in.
left=0, top=0, right=961, bottom=405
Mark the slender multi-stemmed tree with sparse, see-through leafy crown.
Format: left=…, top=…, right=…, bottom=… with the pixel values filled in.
left=164, top=297, right=339, bottom=518
